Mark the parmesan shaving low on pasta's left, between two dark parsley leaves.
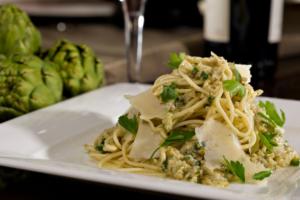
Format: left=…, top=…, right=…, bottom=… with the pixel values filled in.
left=129, top=122, right=163, bottom=160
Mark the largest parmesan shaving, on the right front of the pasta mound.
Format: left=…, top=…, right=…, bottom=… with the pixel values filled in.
left=195, top=119, right=265, bottom=182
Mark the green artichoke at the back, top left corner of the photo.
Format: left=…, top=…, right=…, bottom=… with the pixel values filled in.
left=0, top=4, right=41, bottom=55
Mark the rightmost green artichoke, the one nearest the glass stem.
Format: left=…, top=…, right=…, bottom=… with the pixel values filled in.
left=44, top=40, right=104, bottom=97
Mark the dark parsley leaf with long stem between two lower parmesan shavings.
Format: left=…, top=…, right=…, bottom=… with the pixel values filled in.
left=150, top=130, right=195, bottom=159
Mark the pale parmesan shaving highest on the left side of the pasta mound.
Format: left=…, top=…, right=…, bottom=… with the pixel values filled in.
left=127, top=89, right=167, bottom=120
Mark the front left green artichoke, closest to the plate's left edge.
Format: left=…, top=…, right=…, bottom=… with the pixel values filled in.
left=0, top=55, right=63, bottom=122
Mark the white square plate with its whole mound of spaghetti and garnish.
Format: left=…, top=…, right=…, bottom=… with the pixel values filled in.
left=0, top=53, right=300, bottom=199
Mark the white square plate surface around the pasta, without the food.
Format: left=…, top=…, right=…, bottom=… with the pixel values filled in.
left=0, top=83, right=300, bottom=199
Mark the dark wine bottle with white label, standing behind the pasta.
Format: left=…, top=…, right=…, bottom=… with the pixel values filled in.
left=204, top=0, right=284, bottom=87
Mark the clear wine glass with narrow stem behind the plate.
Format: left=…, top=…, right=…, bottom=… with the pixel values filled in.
left=120, top=0, right=146, bottom=82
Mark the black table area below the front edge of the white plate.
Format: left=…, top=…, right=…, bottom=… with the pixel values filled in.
left=0, top=172, right=199, bottom=200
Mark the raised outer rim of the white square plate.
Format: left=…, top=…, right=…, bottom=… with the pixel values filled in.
left=0, top=83, right=300, bottom=199
